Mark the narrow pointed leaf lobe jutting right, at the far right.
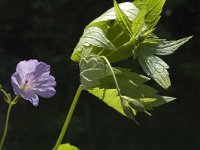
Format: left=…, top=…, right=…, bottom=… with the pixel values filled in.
left=155, top=36, right=192, bottom=55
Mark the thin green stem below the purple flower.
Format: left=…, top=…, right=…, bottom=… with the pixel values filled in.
left=0, top=101, right=13, bottom=150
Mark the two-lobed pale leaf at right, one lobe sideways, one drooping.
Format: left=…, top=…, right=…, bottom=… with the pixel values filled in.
left=137, top=36, right=192, bottom=89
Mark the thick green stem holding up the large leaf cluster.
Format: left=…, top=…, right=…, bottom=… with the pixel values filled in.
left=53, top=85, right=82, bottom=150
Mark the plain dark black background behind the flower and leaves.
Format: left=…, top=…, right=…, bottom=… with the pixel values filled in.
left=0, top=0, right=200, bottom=150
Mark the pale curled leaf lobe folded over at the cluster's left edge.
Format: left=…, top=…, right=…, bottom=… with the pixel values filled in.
left=71, top=27, right=116, bottom=62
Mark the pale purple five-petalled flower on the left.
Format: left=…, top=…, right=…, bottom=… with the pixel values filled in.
left=11, top=59, right=56, bottom=106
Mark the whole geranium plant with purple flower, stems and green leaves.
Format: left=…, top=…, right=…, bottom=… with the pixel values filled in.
left=1, top=0, right=191, bottom=150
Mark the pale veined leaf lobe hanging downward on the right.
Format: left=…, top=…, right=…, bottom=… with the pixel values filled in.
left=138, top=44, right=171, bottom=89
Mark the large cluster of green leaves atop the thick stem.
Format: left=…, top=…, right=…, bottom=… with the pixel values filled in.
left=71, top=0, right=191, bottom=120
